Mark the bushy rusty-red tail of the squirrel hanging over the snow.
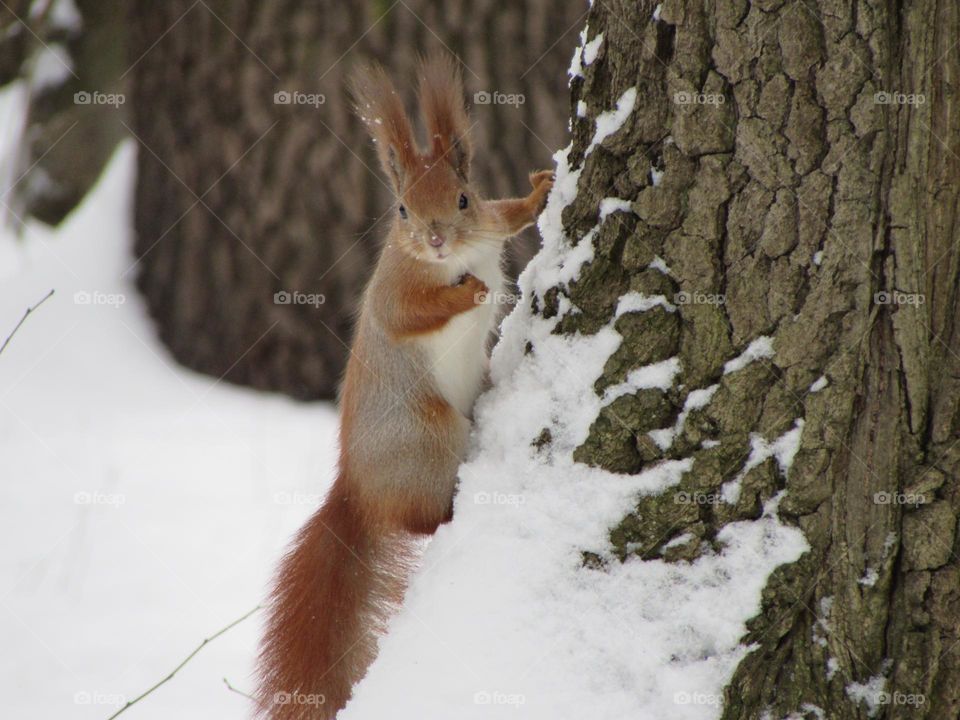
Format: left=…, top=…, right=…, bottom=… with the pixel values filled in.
left=257, top=477, right=409, bottom=720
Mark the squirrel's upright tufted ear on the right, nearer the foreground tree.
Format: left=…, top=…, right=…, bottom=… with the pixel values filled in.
left=419, top=53, right=472, bottom=181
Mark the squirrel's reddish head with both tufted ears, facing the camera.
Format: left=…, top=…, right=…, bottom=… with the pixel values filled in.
left=353, top=54, right=483, bottom=262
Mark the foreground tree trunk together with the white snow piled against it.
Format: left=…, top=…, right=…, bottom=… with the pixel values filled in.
left=344, top=0, right=960, bottom=720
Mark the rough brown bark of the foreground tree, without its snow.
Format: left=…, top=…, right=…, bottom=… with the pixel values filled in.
left=560, top=0, right=960, bottom=720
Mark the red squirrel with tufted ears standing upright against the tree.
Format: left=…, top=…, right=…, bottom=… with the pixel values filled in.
left=256, top=55, right=553, bottom=720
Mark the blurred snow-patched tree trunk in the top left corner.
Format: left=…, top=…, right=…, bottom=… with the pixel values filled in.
left=0, top=0, right=127, bottom=225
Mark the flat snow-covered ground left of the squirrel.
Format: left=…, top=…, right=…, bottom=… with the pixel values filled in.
left=0, top=87, right=336, bottom=720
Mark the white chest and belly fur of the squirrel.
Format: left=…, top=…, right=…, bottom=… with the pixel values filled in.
left=424, top=252, right=504, bottom=417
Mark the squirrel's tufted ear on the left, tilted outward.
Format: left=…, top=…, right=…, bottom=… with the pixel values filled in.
left=350, top=65, right=418, bottom=195
